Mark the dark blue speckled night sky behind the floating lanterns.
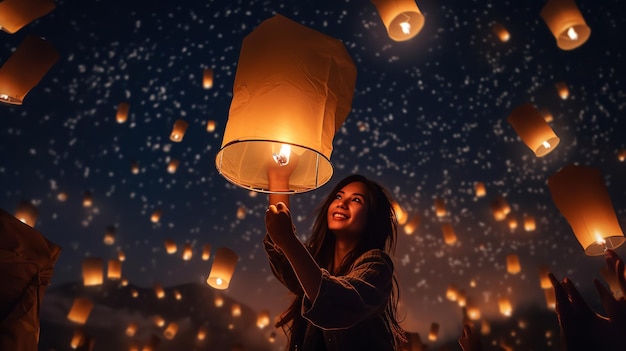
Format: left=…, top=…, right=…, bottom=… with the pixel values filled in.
left=0, top=0, right=626, bottom=348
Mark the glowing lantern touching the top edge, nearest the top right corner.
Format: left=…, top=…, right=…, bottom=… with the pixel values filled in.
left=540, top=0, right=591, bottom=50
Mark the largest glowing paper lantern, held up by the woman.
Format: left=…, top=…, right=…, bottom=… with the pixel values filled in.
left=215, top=15, right=356, bottom=193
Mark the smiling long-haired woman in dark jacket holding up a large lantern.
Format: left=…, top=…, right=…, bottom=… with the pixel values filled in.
left=264, top=175, right=405, bottom=351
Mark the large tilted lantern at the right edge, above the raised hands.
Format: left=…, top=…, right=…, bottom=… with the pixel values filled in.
left=548, top=164, right=625, bottom=256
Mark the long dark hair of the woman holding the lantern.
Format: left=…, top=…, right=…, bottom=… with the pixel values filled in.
left=276, top=174, right=406, bottom=348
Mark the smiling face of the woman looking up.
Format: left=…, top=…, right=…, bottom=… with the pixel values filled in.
left=327, top=182, right=369, bottom=239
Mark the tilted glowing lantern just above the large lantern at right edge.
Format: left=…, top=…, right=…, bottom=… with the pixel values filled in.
left=507, top=103, right=561, bottom=157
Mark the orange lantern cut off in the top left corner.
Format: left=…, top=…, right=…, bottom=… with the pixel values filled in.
left=0, top=0, right=56, bottom=34
